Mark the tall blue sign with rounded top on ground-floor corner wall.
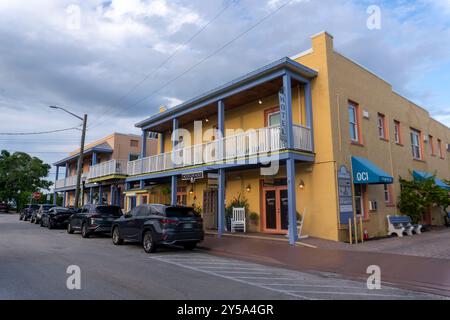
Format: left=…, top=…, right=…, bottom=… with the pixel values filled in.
left=338, top=166, right=353, bottom=225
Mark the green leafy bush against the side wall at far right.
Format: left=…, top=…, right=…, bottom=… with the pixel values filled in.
left=399, top=177, right=450, bottom=223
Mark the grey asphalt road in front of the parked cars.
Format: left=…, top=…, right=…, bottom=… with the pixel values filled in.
left=0, top=215, right=441, bottom=300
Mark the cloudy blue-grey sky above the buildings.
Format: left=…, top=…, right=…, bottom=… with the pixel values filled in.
left=0, top=0, right=450, bottom=181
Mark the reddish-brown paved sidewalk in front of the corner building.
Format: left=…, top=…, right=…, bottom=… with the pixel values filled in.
left=201, top=235, right=450, bottom=297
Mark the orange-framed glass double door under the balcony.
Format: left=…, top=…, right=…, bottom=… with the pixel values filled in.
left=262, top=186, right=289, bottom=234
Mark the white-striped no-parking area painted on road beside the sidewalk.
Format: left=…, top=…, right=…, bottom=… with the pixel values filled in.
left=151, top=253, right=442, bottom=300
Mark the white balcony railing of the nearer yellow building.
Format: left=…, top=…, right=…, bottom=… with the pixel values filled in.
left=127, top=125, right=313, bottom=176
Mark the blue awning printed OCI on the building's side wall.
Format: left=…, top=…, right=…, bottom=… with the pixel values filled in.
left=352, top=157, right=394, bottom=184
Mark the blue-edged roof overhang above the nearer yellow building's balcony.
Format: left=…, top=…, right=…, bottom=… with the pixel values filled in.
left=135, top=57, right=318, bottom=130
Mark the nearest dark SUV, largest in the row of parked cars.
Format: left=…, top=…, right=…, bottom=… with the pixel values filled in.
left=112, top=204, right=205, bottom=253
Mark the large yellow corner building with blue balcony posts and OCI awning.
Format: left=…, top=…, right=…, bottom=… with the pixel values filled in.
left=126, top=32, right=450, bottom=243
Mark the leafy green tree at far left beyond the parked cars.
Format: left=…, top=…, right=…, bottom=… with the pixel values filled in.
left=0, top=150, right=52, bottom=210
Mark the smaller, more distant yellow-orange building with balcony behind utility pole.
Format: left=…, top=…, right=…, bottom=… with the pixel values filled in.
left=54, top=133, right=157, bottom=207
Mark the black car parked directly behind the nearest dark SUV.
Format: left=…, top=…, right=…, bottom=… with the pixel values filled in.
left=67, top=204, right=122, bottom=238
